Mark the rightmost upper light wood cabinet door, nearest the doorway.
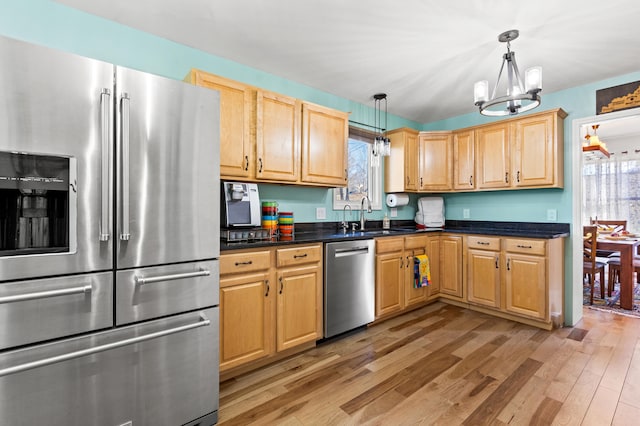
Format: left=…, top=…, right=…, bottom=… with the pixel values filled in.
left=511, top=114, right=558, bottom=187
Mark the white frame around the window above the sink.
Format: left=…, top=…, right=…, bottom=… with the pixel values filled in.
left=330, top=126, right=384, bottom=210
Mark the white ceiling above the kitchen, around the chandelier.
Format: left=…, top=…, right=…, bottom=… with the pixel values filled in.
left=57, top=0, right=640, bottom=123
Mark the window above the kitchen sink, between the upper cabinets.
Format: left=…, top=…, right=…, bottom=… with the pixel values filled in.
left=333, top=127, right=382, bottom=210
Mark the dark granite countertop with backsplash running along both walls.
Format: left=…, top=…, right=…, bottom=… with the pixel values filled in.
left=220, top=220, right=569, bottom=251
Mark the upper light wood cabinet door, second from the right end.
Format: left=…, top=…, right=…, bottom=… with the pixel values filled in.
left=475, top=123, right=510, bottom=189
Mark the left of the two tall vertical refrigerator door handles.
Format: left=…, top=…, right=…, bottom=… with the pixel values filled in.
left=99, top=89, right=111, bottom=241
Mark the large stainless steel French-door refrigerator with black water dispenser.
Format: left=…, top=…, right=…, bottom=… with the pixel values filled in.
left=0, top=38, right=220, bottom=426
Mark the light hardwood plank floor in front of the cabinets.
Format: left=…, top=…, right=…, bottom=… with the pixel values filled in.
left=219, top=303, right=640, bottom=425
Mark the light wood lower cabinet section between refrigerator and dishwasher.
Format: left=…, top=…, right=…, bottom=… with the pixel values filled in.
left=220, top=243, right=322, bottom=372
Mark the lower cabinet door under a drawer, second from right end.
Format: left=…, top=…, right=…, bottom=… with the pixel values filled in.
left=467, top=249, right=500, bottom=308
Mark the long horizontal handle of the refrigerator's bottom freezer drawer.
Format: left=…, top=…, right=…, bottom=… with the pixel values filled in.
left=0, top=313, right=211, bottom=377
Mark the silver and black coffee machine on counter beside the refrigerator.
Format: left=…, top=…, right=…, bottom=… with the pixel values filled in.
left=221, top=182, right=260, bottom=228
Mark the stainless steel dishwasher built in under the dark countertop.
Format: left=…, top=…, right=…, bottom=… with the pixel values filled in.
left=324, top=239, right=376, bottom=338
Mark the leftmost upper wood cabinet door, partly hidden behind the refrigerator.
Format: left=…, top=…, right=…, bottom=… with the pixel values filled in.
left=191, top=71, right=255, bottom=178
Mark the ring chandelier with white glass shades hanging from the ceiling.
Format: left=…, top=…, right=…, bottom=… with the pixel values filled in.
left=473, top=30, right=542, bottom=116
